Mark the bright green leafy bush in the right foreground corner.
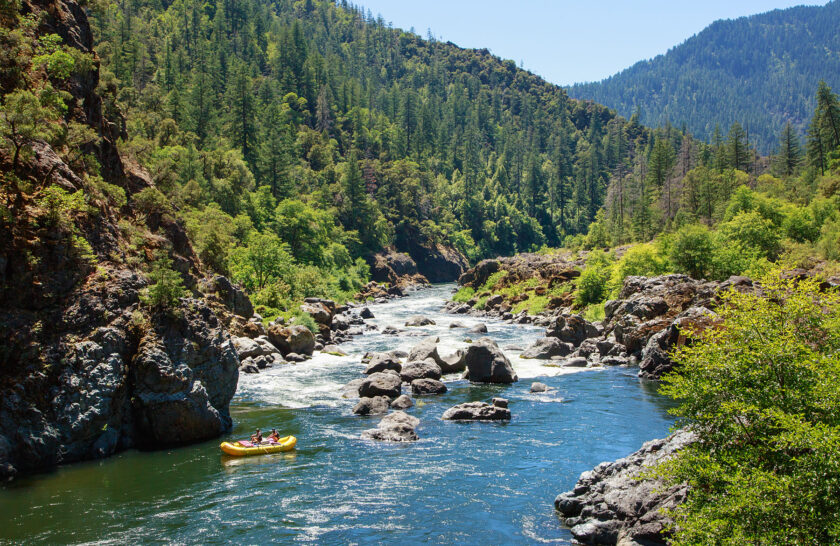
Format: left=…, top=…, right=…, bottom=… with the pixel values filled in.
left=659, top=272, right=840, bottom=544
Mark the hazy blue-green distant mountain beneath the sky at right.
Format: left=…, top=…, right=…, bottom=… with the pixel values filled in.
left=569, top=0, right=840, bottom=152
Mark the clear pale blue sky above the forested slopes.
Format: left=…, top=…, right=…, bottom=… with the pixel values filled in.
left=354, top=0, right=825, bottom=85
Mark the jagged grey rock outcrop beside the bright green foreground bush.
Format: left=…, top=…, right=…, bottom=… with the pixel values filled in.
left=554, top=430, right=695, bottom=545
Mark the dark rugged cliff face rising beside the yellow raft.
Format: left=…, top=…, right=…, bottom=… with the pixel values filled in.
left=0, top=0, right=239, bottom=478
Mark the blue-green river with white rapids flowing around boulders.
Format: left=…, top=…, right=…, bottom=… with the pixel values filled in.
left=0, top=285, right=673, bottom=544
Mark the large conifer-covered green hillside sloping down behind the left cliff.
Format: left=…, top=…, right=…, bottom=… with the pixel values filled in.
left=91, top=0, right=664, bottom=299
